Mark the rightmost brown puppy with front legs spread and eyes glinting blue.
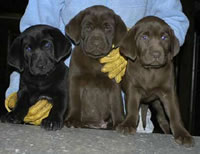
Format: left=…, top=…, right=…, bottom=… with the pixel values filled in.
left=117, top=16, right=193, bottom=146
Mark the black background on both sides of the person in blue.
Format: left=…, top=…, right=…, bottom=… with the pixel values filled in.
left=0, top=0, right=200, bottom=136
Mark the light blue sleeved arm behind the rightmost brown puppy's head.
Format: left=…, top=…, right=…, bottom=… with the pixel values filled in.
left=145, top=0, right=189, bottom=46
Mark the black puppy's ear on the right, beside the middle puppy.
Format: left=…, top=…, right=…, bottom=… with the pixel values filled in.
left=50, top=29, right=72, bottom=62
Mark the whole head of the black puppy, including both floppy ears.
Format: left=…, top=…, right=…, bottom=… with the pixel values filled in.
left=8, top=25, right=71, bottom=75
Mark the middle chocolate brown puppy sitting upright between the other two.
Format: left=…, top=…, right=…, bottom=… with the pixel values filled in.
left=66, top=6, right=126, bottom=129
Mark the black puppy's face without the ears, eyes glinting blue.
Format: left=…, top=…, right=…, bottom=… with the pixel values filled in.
left=22, top=34, right=56, bottom=75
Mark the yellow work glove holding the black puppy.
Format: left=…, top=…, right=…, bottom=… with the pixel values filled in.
left=5, top=93, right=52, bottom=125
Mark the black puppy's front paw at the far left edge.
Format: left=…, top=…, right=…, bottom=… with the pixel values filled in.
left=1, top=112, right=23, bottom=124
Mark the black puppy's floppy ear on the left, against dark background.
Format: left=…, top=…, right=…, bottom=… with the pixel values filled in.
left=7, top=36, right=24, bottom=72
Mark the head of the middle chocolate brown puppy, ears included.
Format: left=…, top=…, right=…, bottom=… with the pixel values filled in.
left=66, top=6, right=126, bottom=58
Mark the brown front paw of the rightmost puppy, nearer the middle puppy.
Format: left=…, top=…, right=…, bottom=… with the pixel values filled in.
left=116, top=123, right=136, bottom=135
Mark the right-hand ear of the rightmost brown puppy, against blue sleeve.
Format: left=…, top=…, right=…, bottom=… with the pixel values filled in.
left=170, top=28, right=180, bottom=57
